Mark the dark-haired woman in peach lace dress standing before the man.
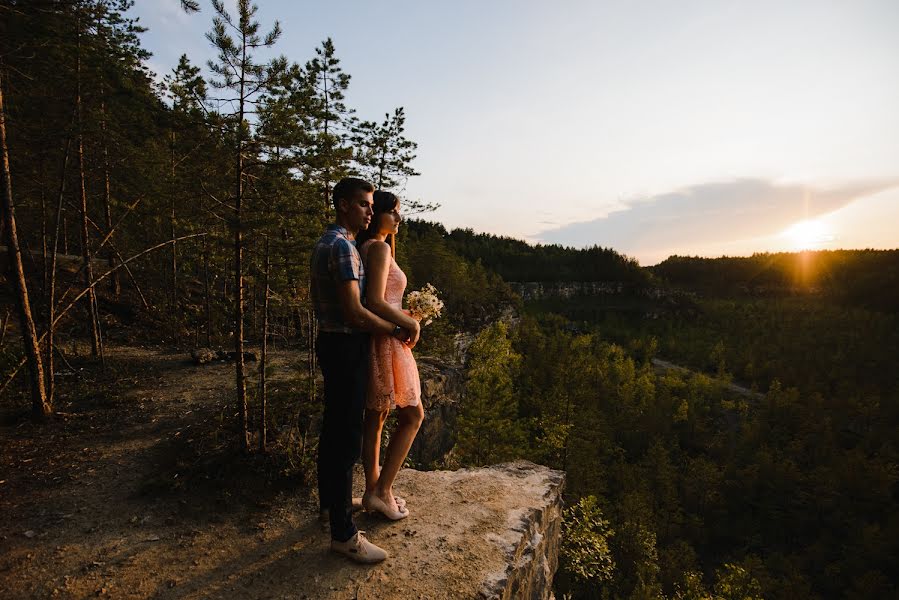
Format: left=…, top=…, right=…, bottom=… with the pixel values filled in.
left=356, top=190, right=424, bottom=520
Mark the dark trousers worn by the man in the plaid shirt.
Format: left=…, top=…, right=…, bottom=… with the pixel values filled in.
left=315, top=331, right=371, bottom=542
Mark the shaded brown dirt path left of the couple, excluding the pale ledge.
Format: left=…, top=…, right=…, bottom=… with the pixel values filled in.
left=0, top=348, right=330, bottom=598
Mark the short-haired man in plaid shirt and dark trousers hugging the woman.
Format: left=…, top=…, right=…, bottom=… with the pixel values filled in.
left=310, top=177, right=421, bottom=563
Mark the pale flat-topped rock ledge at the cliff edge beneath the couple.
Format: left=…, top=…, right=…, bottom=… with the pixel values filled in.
left=306, top=461, right=564, bottom=600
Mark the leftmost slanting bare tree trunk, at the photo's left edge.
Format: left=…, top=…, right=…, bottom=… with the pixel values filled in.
left=0, top=69, right=52, bottom=418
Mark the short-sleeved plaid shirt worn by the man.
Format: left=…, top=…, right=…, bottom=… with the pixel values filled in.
left=310, top=225, right=365, bottom=333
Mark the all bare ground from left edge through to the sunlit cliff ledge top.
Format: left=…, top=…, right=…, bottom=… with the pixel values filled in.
left=0, top=347, right=524, bottom=599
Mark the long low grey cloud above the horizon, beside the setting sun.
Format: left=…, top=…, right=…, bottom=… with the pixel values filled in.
left=532, top=179, right=899, bottom=256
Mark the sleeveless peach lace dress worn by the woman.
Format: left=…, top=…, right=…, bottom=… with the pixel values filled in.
left=359, top=240, right=421, bottom=411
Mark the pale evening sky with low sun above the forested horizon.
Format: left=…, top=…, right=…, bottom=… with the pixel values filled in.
left=132, top=0, right=899, bottom=265
